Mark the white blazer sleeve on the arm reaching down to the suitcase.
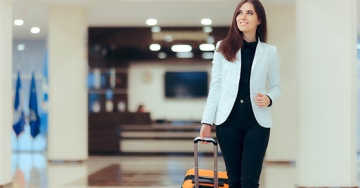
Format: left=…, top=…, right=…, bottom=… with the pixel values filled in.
left=201, top=41, right=222, bottom=125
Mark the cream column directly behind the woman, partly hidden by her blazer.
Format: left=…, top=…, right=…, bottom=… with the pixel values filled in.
left=264, top=1, right=299, bottom=162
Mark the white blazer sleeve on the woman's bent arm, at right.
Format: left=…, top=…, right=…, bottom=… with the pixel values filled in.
left=267, top=46, right=281, bottom=106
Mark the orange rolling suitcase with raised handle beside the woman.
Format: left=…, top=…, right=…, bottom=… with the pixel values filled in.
left=181, top=137, right=229, bottom=188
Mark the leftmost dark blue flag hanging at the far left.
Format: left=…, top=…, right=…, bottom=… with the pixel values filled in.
left=13, top=72, right=25, bottom=137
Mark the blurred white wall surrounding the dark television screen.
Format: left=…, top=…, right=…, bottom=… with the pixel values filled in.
left=128, top=60, right=211, bottom=121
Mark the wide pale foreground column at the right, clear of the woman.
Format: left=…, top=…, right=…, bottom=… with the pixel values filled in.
left=296, top=0, right=358, bottom=187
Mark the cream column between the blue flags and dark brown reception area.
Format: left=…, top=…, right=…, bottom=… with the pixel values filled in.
left=48, top=6, right=88, bottom=161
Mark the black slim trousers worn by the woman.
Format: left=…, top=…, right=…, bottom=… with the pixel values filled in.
left=216, top=99, right=270, bottom=188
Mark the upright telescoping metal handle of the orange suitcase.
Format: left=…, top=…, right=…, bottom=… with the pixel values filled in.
left=194, top=137, right=219, bottom=188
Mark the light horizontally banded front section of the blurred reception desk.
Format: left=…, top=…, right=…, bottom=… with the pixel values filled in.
left=119, top=123, right=215, bottom=154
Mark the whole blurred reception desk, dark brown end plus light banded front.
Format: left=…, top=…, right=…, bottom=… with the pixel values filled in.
left=88, top=113, right=215, bottom=155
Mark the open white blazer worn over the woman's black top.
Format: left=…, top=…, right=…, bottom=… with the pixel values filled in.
left=201, top=39, right=281, bottom=128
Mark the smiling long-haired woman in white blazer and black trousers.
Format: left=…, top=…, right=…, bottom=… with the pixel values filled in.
left=200, top=0, right=281, bottom=188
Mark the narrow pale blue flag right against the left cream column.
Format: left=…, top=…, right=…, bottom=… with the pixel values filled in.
left=40, top=52, right=49, bottom=135
